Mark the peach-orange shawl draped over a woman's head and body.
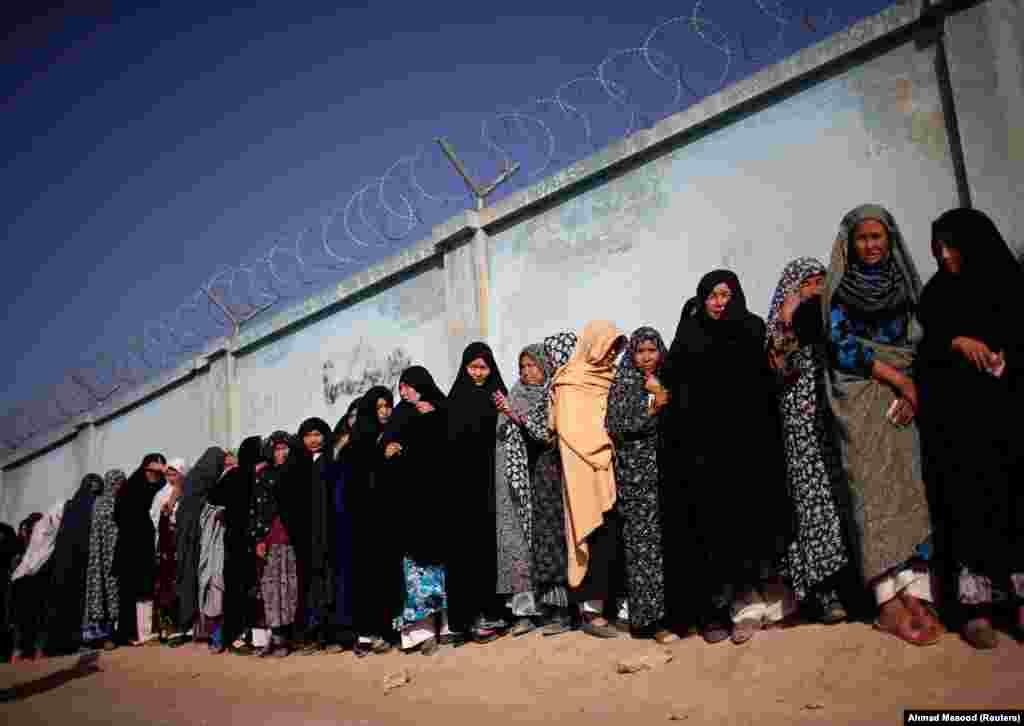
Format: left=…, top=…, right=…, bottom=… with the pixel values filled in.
left=550, top=321, right=625, bottom=588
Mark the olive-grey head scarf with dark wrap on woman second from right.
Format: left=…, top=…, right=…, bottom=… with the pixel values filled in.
left=822, top=204, right=921, bottom=317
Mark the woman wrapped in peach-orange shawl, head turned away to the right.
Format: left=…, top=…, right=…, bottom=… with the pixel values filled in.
left=550, top=321, right=626, bottom=638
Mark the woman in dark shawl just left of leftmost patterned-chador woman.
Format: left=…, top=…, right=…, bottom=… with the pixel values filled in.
left=49, top=474, right=103, bottom=653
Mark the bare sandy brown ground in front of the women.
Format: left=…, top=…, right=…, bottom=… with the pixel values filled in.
left=0, top=624, right=1024, bottom=726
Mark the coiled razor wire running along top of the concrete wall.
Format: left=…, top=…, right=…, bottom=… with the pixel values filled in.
left=0, top=0, right=838, bottom=450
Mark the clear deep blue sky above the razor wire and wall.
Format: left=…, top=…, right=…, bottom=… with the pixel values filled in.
left=0, top=0, right=890, bottom=423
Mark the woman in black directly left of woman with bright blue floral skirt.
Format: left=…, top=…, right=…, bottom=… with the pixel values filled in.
left=341, top=386, right=398, bottom=657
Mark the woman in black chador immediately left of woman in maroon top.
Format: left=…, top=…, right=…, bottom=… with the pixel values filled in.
left=207, top=436, right=263, bottom=648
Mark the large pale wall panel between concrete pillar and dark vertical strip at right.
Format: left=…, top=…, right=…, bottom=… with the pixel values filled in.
left=489, top=38, right=956, bottom=364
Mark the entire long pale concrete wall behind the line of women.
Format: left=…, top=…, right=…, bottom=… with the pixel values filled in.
left=0, top=0, right=1024, bottom=521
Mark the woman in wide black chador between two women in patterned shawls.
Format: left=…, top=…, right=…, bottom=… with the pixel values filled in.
left=662, top=270, right=793, bottom=643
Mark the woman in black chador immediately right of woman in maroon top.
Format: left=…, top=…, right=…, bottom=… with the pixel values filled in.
left=282, top=418, right=335, bottom=655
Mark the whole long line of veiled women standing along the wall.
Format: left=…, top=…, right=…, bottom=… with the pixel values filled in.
left=4, top=205, right=1024, bottom=658
